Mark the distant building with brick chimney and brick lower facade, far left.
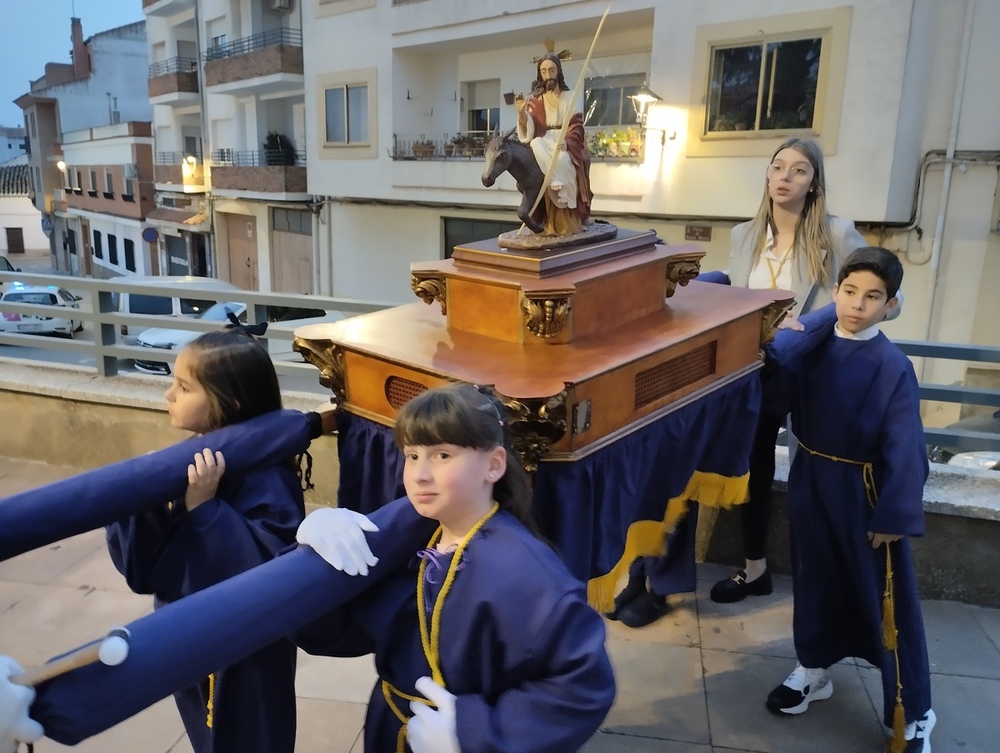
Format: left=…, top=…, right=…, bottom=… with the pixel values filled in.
left=16, top=18, right=155, bottom=277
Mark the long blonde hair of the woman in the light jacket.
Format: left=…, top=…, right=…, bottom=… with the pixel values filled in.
left=750, top=138, right=833, bottom=285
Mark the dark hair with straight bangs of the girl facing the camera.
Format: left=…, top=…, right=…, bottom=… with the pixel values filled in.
left=393, top=383, right=539, bottom=536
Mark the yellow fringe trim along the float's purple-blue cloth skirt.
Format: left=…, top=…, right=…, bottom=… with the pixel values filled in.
left=587, top=471, right=750, bottom=612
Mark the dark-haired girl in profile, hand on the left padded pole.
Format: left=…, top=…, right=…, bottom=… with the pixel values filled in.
left=106, top=327, right=305, bottom=753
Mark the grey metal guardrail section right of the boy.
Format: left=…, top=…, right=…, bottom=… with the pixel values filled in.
left=893, top=340, right=1000, bottom=452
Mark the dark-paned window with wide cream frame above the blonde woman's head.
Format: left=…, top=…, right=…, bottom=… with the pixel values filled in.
left=687, top=6, right=852, bottom=157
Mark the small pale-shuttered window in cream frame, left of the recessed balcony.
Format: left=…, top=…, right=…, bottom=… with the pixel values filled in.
left=316, top=68, right=378, bottom=159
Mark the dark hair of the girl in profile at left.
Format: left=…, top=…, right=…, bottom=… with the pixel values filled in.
left=185, top=327, right=281, bottom=429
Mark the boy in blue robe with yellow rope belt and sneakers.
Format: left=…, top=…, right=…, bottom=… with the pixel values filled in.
left=765, top=247, right=935, bottom=753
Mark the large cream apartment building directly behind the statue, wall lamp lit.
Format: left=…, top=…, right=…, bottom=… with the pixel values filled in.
left=302, top=0, right=1000, bottom=418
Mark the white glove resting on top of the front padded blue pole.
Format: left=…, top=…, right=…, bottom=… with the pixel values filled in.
left=296, top=507, right=378, bottom=576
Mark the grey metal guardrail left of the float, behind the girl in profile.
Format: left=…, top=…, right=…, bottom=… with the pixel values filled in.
left=0, top=272, right=396, bottom=377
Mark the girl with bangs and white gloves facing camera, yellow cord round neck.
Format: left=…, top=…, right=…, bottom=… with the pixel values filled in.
left=296, top=384, right=615, bottom=753
